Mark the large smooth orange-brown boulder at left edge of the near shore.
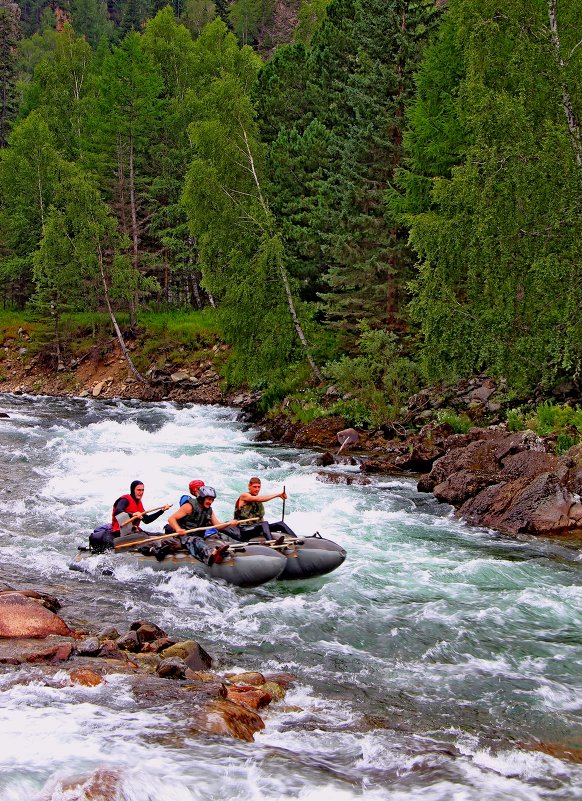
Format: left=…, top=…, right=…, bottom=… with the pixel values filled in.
left=0, top=592, right=73, bottom=639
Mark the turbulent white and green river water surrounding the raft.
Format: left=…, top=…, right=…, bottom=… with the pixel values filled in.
left=0, top=395, right=582, bottom=801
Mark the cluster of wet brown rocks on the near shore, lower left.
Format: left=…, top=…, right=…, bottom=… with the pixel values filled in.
left=0, top=585, right=294, bottom=748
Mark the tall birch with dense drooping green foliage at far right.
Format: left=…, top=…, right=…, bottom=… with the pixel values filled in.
left=403, top=0, right=582, bottom=392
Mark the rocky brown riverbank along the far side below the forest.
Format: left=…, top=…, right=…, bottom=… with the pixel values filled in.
left=0, top=332, right=582, bottom=541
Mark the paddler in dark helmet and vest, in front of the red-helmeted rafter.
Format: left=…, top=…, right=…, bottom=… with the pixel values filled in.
left=166, top=482, right=238, bottom=565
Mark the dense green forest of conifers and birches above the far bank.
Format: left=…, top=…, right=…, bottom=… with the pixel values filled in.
left=0, top=0, right=582, bottom=424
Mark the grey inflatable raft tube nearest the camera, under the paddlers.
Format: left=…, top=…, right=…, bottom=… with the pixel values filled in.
left=69, top=541, right=287, bottom=587
